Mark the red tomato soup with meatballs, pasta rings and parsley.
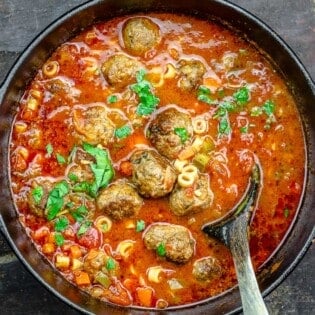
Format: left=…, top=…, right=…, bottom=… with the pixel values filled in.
left=10, top=13, right=305, bottom=308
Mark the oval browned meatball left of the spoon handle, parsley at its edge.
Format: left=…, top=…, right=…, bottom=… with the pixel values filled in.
left=143, top=223, right=195, bottom=263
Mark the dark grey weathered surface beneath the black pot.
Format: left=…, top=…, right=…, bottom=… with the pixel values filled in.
left=0, top=0, right=315, bottom=315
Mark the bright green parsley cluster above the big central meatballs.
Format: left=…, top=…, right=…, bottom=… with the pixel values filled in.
left=130, top=69, right=160, bottom=116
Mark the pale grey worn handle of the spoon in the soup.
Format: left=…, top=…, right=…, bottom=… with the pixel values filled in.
left=229, top=214, right=268, bottom=315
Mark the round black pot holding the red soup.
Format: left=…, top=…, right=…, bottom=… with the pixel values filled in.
left=0, top=0, right=315, bottom=314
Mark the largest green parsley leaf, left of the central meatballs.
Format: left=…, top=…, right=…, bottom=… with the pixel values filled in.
left=83, top=143, right=114, bottom=197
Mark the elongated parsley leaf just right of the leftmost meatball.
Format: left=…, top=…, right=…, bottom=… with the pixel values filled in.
left=46, top=180, right=69, bottom=220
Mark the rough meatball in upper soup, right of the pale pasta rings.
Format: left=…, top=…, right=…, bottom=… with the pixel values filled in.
left=178, top=59, right=206, bottom=91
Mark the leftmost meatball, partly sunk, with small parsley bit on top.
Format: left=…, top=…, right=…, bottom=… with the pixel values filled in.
left=27, top=177, right=54, bottom=217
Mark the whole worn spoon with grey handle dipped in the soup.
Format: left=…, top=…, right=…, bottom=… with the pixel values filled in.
left=202, top=164, right=268, bottom=315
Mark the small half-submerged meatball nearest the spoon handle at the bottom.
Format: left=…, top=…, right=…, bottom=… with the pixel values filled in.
left=192, top=256, right=222, bottom=281
